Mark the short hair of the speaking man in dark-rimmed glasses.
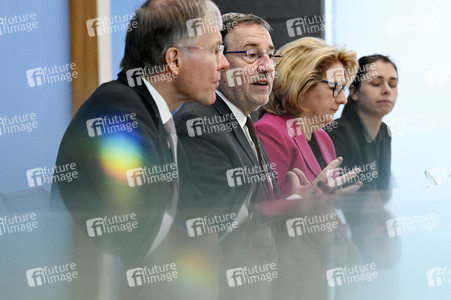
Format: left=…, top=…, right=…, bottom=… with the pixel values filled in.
left=221, top=13, right=272, bottom=51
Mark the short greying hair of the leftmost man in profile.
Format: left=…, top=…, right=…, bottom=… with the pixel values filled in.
left=121, top=0, right=221, bottom=70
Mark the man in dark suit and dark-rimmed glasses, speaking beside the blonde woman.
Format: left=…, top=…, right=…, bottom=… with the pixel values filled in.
left=174, top=13, right=278, bottom=220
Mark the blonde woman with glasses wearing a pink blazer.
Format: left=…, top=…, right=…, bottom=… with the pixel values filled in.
left=255, top=37, right=357, bottom=196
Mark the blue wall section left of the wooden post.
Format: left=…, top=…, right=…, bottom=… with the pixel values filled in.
left=0, top=0, right=71, bottom=193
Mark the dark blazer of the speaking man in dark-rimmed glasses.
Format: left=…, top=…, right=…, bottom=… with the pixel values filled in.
left=174, top=96, right=279, bottom=214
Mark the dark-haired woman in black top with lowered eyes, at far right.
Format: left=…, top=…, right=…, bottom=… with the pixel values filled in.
left=329, top=54, right=398, bottom=191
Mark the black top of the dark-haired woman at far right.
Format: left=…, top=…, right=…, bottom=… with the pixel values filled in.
left=329, top=109, right=391, bottom=191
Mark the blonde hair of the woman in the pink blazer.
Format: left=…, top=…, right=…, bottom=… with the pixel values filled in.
left=263, top=37, right=357, bottom=116
